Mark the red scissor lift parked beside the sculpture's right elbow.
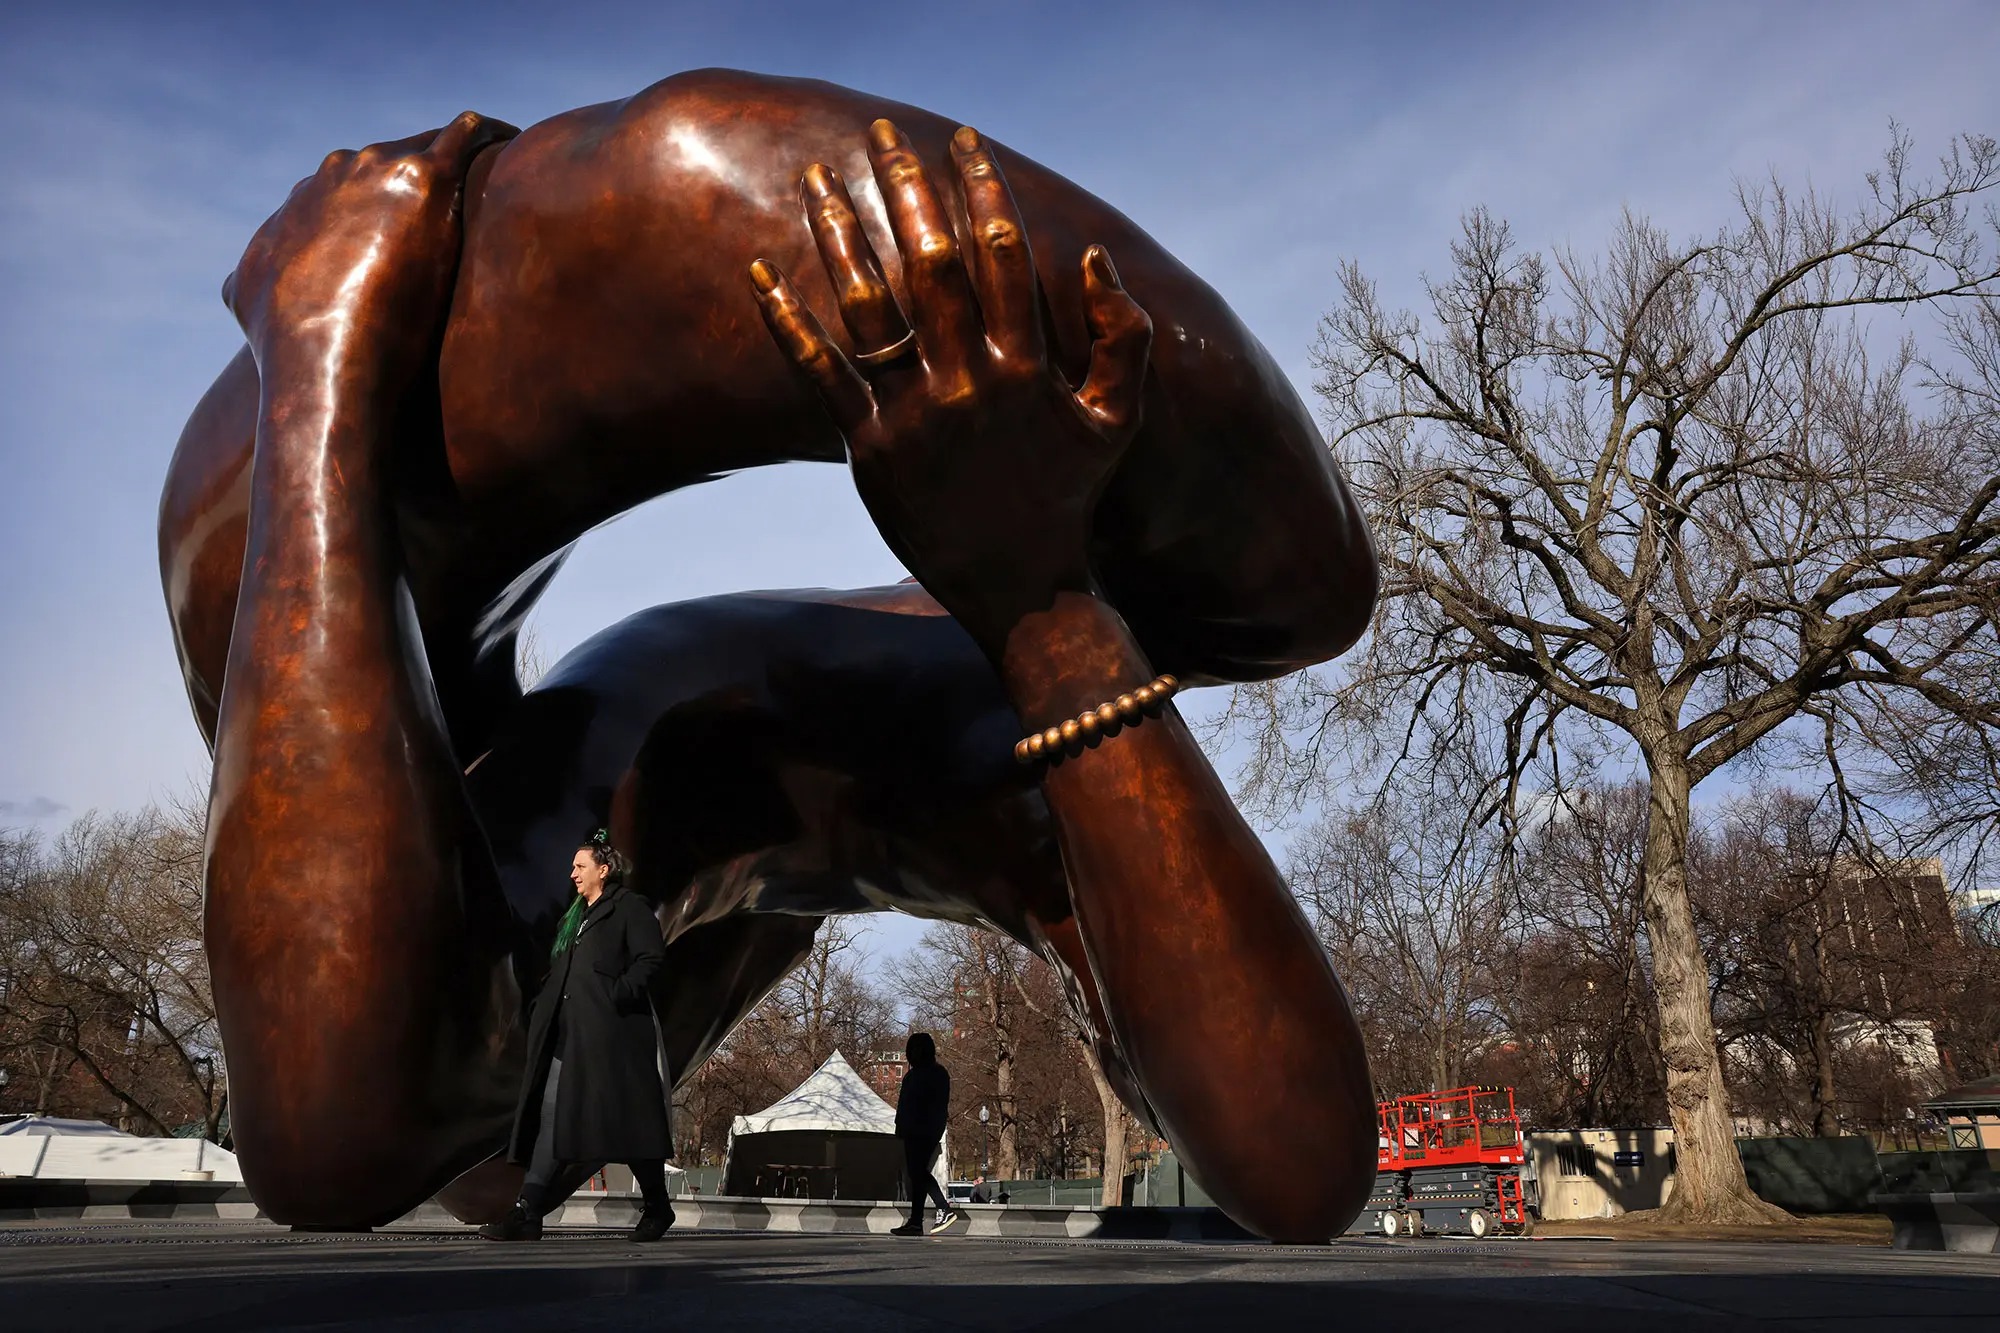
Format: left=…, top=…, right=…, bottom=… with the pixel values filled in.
left=1352, top=1087, right=1528, bottom=1237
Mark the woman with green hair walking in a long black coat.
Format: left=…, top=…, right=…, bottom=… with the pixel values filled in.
left=480, top=829, right=674, bottom=1241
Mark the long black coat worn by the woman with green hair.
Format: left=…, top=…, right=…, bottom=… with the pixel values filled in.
left=508, top=887, right=674, bottom=1163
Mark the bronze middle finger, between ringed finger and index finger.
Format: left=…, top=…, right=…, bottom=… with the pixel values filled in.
left=868, top=120, right=984, bottom=378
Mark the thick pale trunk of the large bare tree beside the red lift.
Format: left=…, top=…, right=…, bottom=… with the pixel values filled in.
left=1640, top=755, right=1790, bottom=1225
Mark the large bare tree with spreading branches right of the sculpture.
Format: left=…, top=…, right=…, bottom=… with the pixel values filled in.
left=1244, top=132, right=2000, bottom=1221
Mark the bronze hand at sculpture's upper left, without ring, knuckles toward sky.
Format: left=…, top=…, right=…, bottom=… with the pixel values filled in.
left=222, top=112, right=520, bottom=376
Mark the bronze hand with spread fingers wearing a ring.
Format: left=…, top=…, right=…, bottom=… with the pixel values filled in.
left=750, top=120, right=1152, bottom=654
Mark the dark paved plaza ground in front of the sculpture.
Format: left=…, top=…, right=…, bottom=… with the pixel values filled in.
left=0, top=1223, right=2000, bottom=1333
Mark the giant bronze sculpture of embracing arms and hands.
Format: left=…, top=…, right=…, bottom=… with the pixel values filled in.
left=160, top=72, right=1376, bottom=1239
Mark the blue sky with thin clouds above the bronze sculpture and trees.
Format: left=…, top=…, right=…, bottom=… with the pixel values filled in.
left=0, top=0, right=2000, bottom=956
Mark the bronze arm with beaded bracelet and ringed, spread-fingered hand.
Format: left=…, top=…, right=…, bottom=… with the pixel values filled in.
left=750, top=120, right=1374, bottom=1241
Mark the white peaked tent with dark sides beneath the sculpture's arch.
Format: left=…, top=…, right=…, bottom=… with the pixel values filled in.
left=722, top=1051, right=950, bottom=1199
